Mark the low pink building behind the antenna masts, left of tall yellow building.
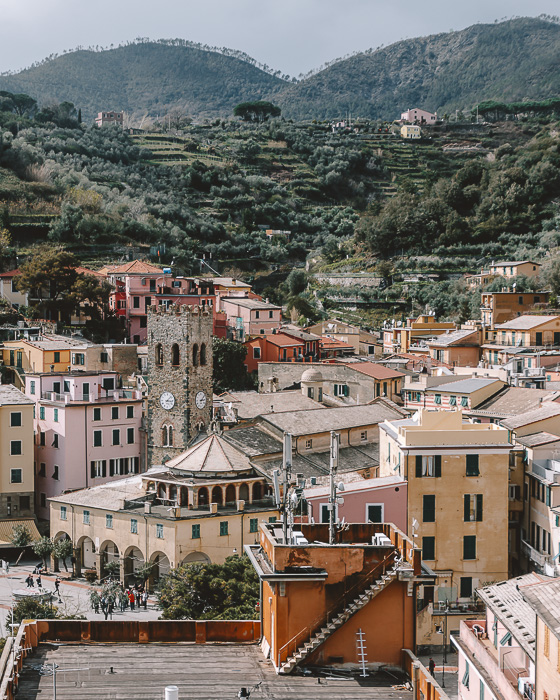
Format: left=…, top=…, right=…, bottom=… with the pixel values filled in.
left=304, top=476, right=407, bottom=533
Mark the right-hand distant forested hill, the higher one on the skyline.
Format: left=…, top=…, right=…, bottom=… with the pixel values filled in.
left=279, top=18, right=560, bottom=119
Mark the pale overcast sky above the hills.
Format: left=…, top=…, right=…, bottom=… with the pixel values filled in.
left=0, top=0, right=560, bottom=75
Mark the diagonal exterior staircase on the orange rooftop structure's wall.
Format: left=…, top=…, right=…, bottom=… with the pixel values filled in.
left=278, top=563, right=399, bottom=674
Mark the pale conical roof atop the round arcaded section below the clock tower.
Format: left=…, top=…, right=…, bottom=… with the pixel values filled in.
left=165, top=435, right=252, bottom=474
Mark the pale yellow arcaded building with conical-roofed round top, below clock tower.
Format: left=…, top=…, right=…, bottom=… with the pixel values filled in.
left=50, top=435, right=278, bottom=586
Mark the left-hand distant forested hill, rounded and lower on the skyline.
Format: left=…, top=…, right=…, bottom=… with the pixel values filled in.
left=0, top=42, right=286, bottom=120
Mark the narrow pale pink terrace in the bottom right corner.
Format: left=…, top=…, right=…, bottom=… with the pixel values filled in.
left=452, top=620, right=536, bottom=700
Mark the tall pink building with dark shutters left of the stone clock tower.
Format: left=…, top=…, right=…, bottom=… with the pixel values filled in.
left=25, top=372, right=145, bottom=519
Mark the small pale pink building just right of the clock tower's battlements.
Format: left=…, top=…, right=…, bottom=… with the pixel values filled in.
left=221, top=297, right=282, bottom=342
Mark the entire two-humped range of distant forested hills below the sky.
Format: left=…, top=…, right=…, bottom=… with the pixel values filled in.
left=0, top=18, right=560, bottom=120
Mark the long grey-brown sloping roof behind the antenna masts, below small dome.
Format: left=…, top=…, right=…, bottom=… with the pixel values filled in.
left=260, top=403, right=406, bottom=436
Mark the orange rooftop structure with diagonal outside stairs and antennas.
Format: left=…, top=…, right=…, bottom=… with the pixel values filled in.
left=245, top=523, right=433, bottom=673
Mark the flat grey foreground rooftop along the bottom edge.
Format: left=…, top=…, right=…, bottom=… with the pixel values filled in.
left=17, top=643, right=412, bottom=700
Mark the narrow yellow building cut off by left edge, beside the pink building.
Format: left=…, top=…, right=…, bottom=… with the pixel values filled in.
left=0, top=384, right=35, bottom=519
